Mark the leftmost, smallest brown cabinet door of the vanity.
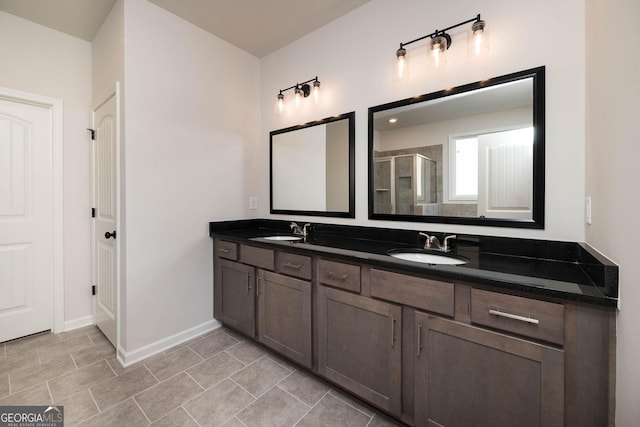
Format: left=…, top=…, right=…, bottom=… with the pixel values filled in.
left=213, top=258, right=256, bottom=337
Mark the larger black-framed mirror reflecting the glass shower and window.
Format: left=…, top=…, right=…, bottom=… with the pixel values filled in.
left=369, top=67, right=545, bottom=228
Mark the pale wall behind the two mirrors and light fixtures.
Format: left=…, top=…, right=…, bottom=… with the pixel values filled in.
left=258, top=0, right=585, bottom=241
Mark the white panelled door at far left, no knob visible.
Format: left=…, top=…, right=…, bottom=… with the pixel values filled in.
left=0, top=98, right=53, bottom=342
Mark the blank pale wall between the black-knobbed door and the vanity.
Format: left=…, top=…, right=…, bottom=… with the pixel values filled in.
left=122, top=0, right=260, bottom=360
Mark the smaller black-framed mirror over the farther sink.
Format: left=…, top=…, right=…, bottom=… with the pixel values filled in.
left=269, top=112, right=355, bottom=218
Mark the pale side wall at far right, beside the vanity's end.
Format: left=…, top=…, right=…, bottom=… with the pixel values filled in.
left=586, top=0, right=640, bottom=427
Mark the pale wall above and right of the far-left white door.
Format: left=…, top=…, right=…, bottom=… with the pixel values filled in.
left=0, top=12, right=92, bottom=325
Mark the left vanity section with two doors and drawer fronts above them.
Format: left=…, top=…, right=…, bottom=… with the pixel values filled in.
left=213, top=239, right=312, bottom=368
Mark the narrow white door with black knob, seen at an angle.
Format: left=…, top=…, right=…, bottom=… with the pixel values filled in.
left=92, top=93, right=119, bottom=347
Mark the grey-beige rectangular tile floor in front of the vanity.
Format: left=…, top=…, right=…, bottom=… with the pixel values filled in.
left=0, top=326, right=396, bottom=427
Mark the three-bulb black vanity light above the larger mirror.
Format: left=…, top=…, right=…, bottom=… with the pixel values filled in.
left=396, top=14, right=489, bottom=78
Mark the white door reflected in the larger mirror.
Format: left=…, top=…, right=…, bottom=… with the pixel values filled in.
left=478, top=127, right=533, bottom=219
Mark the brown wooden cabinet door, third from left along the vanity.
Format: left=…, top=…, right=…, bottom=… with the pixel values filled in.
left=318, top=286, right=402, bottom=415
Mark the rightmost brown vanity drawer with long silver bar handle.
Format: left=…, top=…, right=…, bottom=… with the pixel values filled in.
left=471, top=289, right=564, bottom=345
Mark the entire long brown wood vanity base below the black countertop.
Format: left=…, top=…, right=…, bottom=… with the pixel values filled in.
left=214, top=239, right=615, bottom=427
